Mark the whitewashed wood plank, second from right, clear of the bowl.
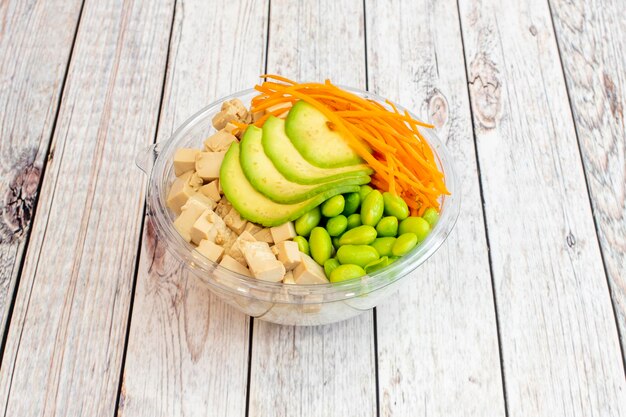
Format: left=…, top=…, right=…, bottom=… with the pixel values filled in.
left=460, top=0, right=626, bottom=417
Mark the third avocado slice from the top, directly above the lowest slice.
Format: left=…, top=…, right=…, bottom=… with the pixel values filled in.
left=239, top=126, right=370, bottom=204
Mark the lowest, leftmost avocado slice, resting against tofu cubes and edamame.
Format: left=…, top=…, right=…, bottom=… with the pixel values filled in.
left=220, top=143, right=359, bottom=227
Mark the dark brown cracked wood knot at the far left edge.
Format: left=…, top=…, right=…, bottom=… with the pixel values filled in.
left=0, top=163, right=41, bottom=243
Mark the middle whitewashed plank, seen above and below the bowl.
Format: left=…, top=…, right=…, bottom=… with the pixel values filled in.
left=249, top=0, right=376, bottom=417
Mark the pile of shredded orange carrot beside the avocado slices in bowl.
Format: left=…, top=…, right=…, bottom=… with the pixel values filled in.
left=236, top=74, right=449, bottom=215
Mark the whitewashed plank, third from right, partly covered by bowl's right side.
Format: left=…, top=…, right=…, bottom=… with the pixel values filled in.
left=366, top=0, right=505, bottom=417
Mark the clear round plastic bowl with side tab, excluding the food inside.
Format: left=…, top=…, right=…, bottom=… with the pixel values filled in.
left=137, top=87, right=460, bottom=325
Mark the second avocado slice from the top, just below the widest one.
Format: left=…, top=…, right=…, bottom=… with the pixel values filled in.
left=263, top=116, right=372, bottom=184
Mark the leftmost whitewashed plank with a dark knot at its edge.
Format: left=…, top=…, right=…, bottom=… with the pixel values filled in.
left=0, top=0, right=82, bottom=334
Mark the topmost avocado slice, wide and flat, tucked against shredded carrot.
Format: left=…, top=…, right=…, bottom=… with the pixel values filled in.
left=285, top=100, right=363, bottom=168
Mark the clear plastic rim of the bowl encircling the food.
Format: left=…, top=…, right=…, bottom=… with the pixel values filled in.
left=146, top=85, right=461, bottom=300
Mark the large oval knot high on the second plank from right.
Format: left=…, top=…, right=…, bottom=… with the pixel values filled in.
left=469, top=54, right=502, bottom=129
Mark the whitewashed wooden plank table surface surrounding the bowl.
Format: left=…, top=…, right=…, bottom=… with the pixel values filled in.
left=0, top=0, right=626, bottom=417
